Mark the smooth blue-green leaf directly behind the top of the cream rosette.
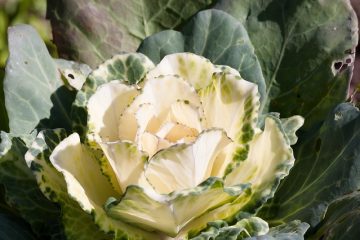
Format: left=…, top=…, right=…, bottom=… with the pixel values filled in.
left=138, top=10, right=265, bottom=105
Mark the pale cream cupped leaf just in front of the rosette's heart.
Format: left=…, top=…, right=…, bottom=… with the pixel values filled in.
left=145, top=130, right=231, bottom=193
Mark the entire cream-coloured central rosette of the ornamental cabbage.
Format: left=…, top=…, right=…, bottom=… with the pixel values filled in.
left=43, top=53, right=303, bottom=237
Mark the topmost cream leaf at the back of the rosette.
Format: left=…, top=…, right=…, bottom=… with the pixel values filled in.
left=147, top=53, right=215, bottom=89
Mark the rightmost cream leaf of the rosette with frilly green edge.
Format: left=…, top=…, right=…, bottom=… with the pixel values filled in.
left=225, top=116, right=299, bottom=213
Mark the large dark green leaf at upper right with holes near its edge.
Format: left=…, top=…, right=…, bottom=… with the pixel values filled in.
left=216, top=0, right=358, bottom=129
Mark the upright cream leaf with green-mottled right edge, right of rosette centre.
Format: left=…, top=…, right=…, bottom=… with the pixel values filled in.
left=199, top=73, right=260, bottom=177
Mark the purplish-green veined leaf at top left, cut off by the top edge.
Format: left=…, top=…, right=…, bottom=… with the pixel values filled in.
left=47, top=0, right=216, bottom=67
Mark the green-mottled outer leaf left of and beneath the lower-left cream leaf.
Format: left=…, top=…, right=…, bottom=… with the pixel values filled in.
left=26, top=129, right=113, bottom=240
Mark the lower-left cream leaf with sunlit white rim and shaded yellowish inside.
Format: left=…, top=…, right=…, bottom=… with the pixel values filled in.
left=50, top=133, right=118, bottom=213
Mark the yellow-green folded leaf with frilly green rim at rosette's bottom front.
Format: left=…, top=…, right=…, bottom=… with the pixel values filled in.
left=106, top=178, right=248, bottom=239
